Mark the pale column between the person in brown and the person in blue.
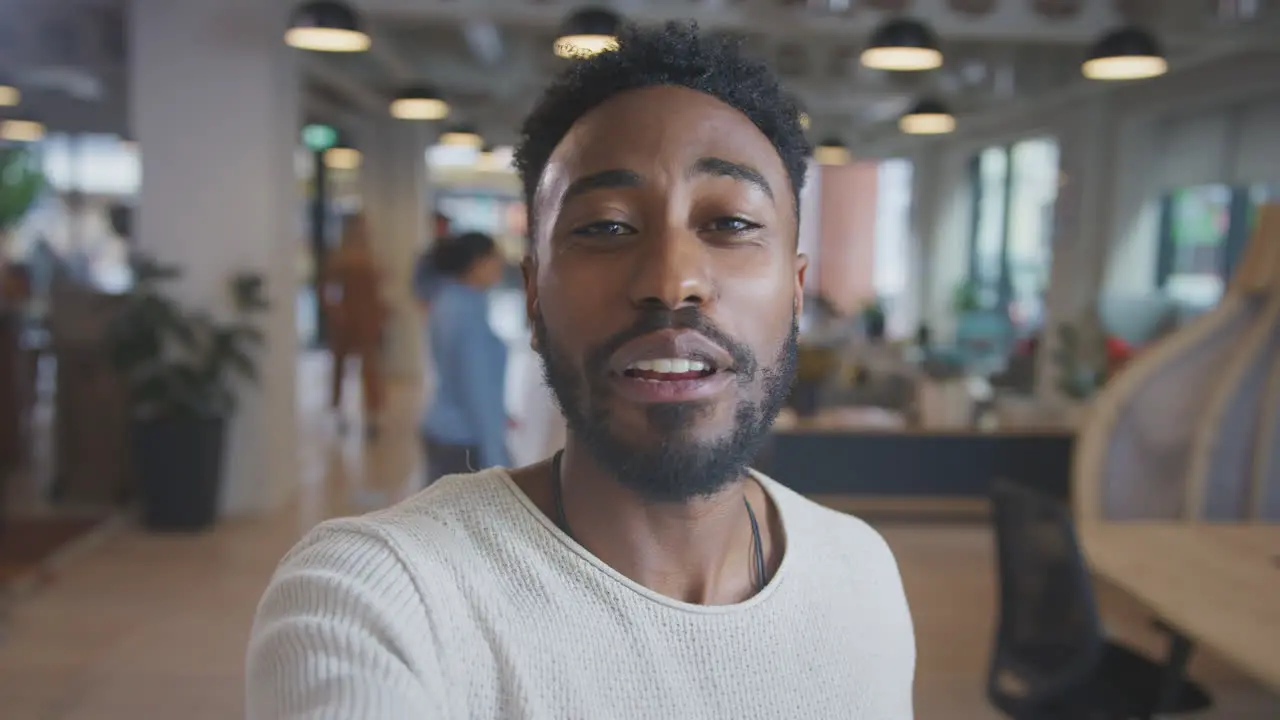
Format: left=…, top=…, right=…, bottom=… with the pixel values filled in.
left=360, top=115, right=434, bottom=380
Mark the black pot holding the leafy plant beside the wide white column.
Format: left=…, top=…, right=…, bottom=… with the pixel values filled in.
left=133, top=418, right=227, bottom=533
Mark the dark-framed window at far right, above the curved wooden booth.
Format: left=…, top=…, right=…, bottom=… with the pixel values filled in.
left=1156, top=184, right=1264, bottom=309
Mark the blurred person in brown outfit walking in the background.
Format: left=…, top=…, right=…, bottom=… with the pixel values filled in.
left=320, top=213, right=387, bottom=438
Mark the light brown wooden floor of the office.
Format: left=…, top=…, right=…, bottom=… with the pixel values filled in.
left=0, top=356, right=1280, bottom=720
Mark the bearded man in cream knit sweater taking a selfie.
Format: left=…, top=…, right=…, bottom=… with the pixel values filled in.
left=247, top=26, right=915, bottom=720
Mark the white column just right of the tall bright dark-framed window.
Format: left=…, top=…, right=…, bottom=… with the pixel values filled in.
left=1036, top=97, right=1117, bottom=401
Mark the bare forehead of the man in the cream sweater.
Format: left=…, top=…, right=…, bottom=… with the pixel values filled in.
left=535, top=87, right=791, bottom=210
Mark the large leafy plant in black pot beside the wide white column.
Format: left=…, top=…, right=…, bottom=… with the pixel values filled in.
left=108, top=256, right=269, bottom=530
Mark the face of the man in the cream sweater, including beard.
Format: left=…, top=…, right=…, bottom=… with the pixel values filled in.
left=525, top=87, right=805, bottom=501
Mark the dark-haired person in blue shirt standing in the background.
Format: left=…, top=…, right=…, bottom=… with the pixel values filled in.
left=421, top=232, right=511, bottom=483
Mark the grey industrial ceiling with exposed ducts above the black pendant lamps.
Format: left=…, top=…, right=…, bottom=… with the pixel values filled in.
left=0, top=0, right=1280, bottom=143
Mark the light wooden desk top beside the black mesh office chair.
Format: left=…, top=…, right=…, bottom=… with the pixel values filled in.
left=1080, top=523, right=1280, bottom=691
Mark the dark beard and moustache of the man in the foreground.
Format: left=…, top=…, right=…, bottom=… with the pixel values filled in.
left=532, top=307, right=800, bottom=503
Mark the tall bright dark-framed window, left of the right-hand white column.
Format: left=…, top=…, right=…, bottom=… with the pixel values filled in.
left=969, top=138, right=1059, bottom=328
